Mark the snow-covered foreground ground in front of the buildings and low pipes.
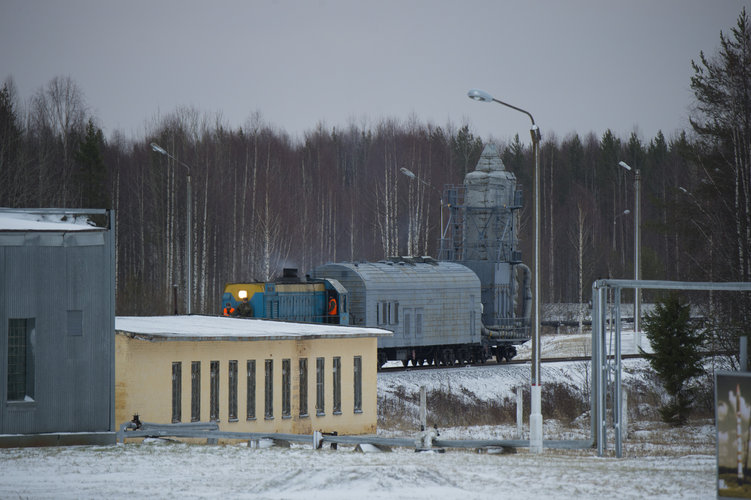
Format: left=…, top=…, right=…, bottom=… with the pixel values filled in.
left=0, top=438, right=715, bottom=499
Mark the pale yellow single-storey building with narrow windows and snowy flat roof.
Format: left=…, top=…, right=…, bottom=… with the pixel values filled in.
left=115, top=316, right=392, bottom=434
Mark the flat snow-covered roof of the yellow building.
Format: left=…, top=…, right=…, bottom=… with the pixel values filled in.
left=115, top=315, right=393, bottom=341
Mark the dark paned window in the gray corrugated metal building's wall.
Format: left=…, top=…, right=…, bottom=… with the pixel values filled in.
left=8, top=319, right=34, bottom=401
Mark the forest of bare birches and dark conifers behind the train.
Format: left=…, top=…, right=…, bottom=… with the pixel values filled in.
left=0, top=11, right=751, bottom=315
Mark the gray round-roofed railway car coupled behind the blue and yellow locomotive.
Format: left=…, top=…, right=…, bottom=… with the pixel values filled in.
left=310, top=257, right=484, bottom=366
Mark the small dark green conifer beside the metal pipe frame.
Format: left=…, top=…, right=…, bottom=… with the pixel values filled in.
left=642, top=294, right=704, bottom=426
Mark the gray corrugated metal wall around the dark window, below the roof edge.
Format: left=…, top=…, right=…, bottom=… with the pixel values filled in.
left=0, top=213, right=114, bottom=434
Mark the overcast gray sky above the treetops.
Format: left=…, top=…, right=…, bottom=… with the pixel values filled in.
left=0, top=0, right=751, bottom=142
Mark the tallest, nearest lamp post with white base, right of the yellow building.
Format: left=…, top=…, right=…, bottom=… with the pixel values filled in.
left=467, top=89, right=542, bottom=453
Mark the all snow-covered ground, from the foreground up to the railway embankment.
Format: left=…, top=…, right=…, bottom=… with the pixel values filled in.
left=0, top=335, right=716, bottom=499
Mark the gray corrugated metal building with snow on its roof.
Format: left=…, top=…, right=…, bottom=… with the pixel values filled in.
left=0, top=209, right=115, bottom=446
